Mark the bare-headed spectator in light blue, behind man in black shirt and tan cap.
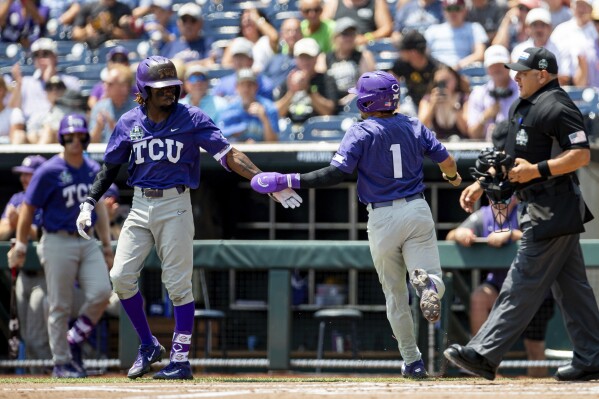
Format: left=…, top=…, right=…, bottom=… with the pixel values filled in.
left=262, top=18, right=302, bottom=92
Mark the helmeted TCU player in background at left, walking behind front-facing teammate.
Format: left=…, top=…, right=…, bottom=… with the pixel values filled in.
left=9, top=114, right=112, bottom=378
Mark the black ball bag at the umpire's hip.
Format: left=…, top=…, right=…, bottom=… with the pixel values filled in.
left=523, top=176, right=593, bottom=241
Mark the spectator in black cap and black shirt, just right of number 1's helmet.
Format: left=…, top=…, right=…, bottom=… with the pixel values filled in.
left=391, top=30, right=439, bottom=116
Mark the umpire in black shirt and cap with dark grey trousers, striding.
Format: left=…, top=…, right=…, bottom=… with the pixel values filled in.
left=444, top=47, right=599, bottom=381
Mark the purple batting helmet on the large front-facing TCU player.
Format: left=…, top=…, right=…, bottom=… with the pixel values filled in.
left=136, top=55, right=183, bottom=101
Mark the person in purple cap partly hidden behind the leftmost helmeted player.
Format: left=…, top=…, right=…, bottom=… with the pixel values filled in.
left=0, top=155, right=52, bottom=368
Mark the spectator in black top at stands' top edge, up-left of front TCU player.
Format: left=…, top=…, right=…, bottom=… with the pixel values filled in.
left=73, top=0, right=131, bottom=48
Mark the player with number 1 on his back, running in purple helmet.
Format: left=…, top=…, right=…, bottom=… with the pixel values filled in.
left=251, top=71, right=462, bottom=378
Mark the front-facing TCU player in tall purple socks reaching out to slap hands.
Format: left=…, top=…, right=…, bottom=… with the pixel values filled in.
left=77, top=56, right=301, bottom=379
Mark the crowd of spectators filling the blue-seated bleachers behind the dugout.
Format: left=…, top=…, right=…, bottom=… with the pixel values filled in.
left=0, top=0, right=599, bottom=144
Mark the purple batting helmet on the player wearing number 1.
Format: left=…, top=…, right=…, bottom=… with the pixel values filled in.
left=348, top=71, right=399, bottom=112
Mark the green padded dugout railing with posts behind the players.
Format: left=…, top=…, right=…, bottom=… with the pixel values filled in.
left=0, top=239, right=599, bottom=373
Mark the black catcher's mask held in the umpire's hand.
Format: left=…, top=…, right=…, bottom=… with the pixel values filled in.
left=470, top=147, right=515, bottom=231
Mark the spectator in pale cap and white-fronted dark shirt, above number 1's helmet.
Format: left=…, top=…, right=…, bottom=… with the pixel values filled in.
left=324, top=17, right=375, bottom=112
